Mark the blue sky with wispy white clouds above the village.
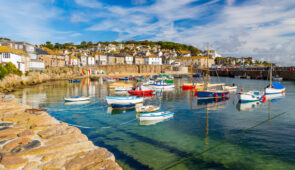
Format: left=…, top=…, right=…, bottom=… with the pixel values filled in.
left=0, top=0, right=295, bottom=65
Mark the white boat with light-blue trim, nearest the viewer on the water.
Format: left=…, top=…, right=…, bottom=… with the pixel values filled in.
left=138, top=111, right=174, bottom=121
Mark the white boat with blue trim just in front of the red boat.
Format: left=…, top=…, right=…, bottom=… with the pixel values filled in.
left=106, top=96, right=143, bottom=105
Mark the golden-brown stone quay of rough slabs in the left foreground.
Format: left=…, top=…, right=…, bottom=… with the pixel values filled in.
left=0, top=94, right=122, bottom=170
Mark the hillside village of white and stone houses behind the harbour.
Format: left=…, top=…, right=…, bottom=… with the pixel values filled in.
left=0, top=39, right=265, bottom=73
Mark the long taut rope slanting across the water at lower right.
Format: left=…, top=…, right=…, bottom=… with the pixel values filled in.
left=160, top=112, right=287, bottom=169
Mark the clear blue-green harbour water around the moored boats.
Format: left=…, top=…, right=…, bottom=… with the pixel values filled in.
left=15, top=78, right=295, bottom=169
